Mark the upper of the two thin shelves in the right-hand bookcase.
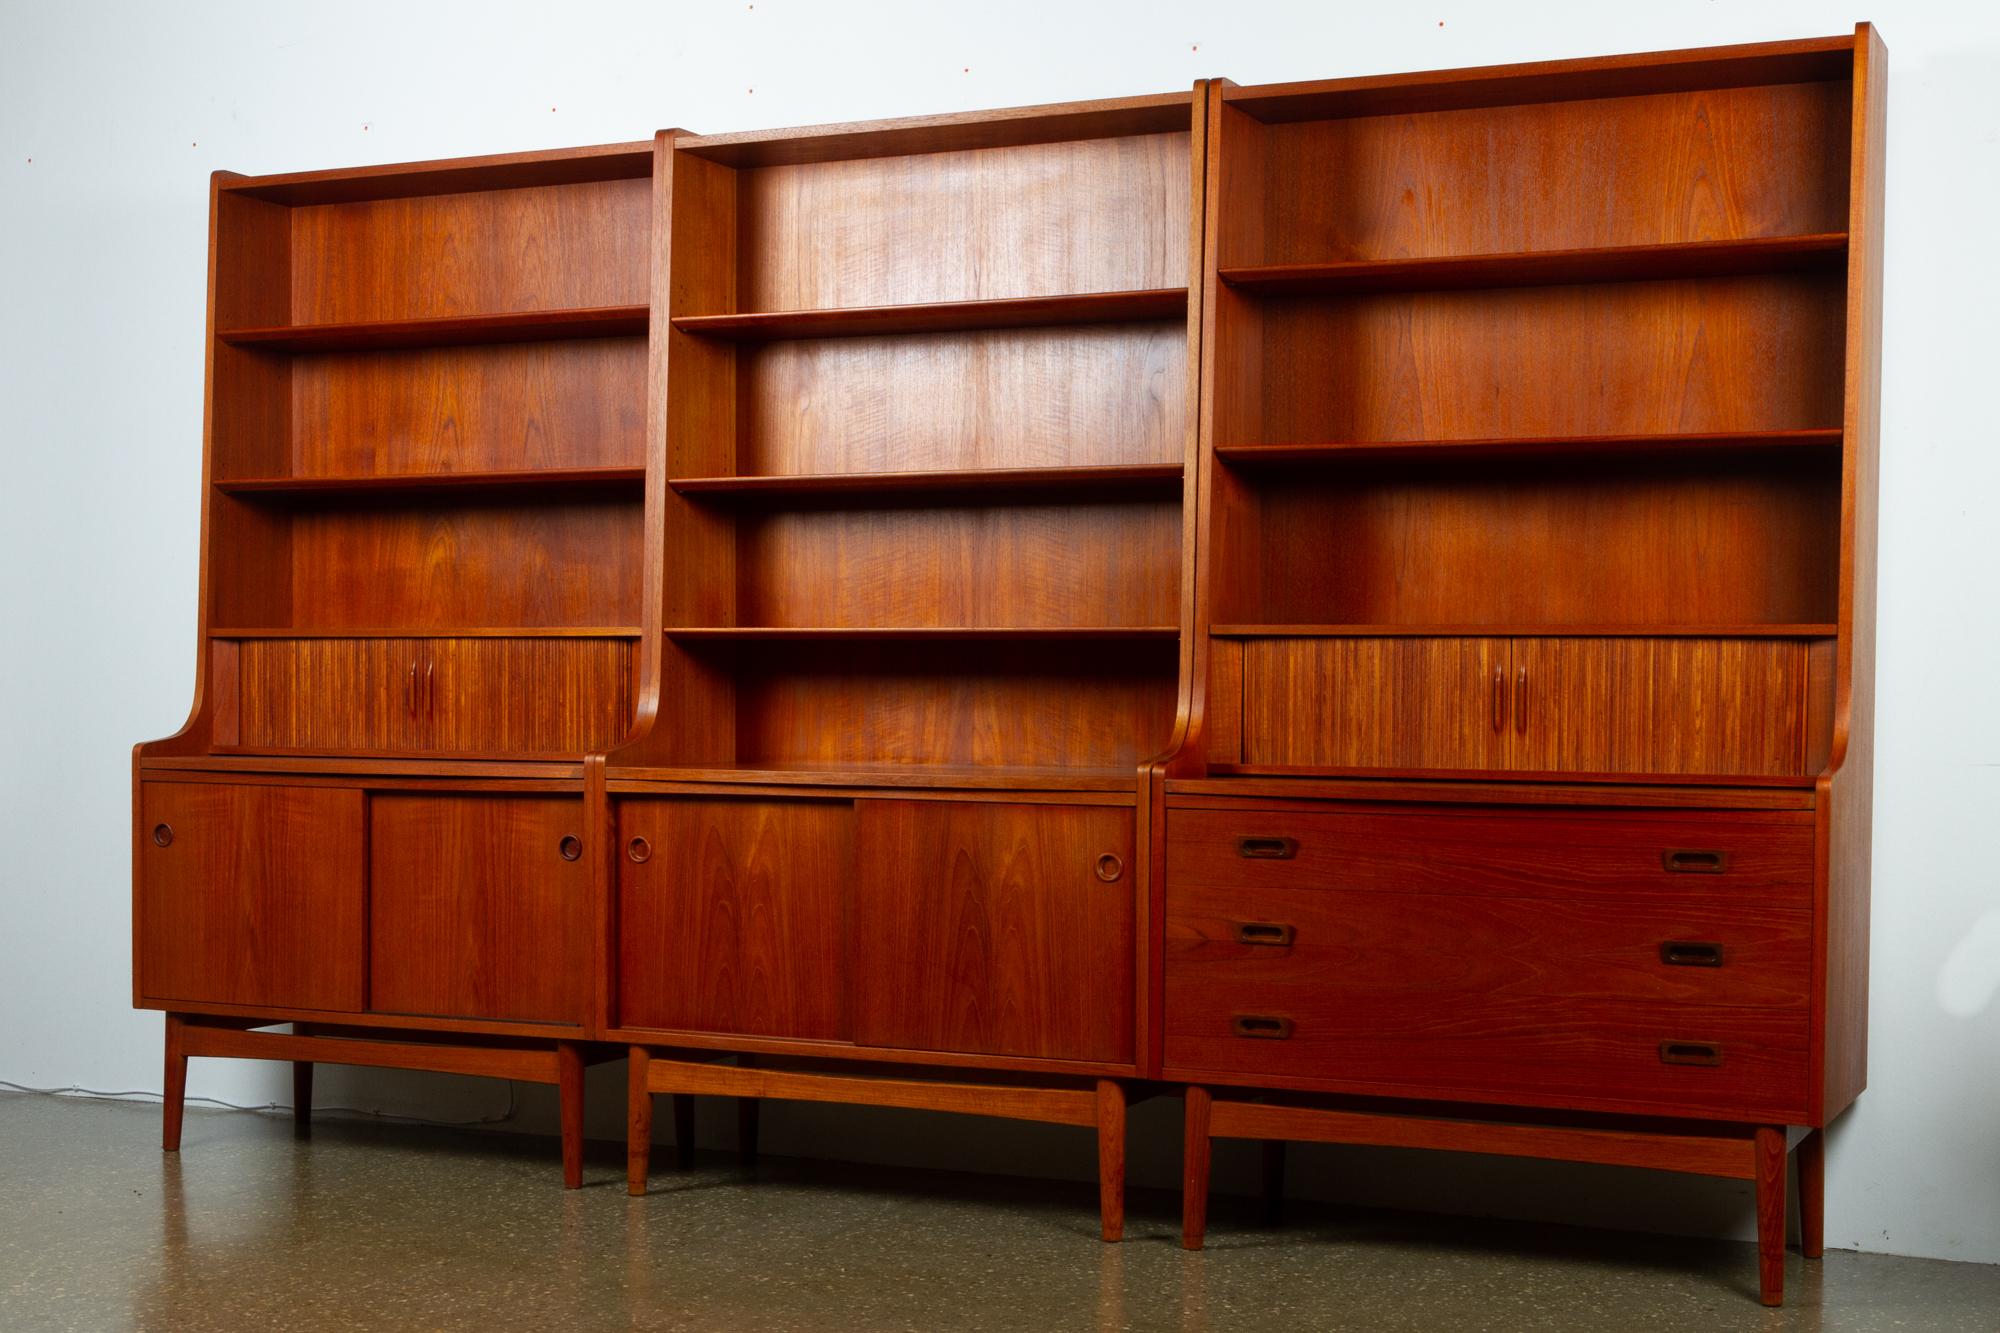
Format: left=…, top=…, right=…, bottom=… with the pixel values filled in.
left=1218, top=232, right=1848, bottom=296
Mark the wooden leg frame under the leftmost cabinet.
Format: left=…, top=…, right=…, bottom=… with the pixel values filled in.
left=160, top=1013, right=614, bottom=1189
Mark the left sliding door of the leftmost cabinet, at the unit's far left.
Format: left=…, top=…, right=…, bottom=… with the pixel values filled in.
left=136, top=783, right=364, bottom=1011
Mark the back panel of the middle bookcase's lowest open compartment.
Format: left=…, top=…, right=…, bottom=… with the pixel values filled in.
left=736, top=642, right=1178, bottom=769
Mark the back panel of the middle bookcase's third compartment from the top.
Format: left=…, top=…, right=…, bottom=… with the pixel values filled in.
left=736, top=500, right=1180, bottom=626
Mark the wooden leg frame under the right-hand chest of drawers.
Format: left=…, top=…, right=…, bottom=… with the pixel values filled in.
left=1180, top=1085, right=1826, bottom=1305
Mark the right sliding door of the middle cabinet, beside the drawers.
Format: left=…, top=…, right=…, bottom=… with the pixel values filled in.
left=852, top=801, right=1134, bottom=1063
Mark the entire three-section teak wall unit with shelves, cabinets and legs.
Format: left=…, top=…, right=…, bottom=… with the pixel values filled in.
left=134, top=24, right=1886, bottom=1303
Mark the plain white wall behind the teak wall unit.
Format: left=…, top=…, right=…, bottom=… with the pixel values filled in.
left=0, top=0, right=2000, bottom=1261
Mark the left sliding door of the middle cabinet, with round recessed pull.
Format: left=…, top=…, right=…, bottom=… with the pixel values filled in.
left=614, top=797, right=854, bottom=1041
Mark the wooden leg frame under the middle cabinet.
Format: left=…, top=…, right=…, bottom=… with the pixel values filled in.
left=626, top=1047, right=1128, bottom=1241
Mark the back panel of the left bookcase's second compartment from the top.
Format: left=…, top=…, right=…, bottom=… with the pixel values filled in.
left=270, top=338, right=646, bottom=476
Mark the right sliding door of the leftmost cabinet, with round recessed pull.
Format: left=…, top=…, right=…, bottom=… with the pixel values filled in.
left=368, top=793, right=590, bottom=1023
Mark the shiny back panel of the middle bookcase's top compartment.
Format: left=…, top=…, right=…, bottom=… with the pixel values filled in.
left=736, top=134, right=1190, bottom=310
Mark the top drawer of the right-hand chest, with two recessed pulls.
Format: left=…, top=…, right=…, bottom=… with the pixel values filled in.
left=1166, top=807, right=1812, bottom=909
